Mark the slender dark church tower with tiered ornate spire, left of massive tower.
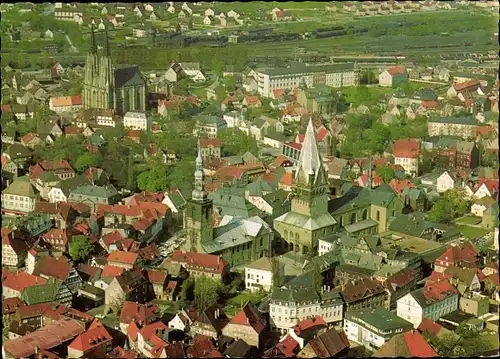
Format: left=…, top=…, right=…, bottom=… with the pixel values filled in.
left=184, top=145, right=214, bottom=252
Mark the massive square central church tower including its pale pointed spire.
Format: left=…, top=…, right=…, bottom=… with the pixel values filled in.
left=274, top=119, right=337, bottom=255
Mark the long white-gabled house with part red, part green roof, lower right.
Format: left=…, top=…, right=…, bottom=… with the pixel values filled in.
left=397, top=280, right=458, bottom=328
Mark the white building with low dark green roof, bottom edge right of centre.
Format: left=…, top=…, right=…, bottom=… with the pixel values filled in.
left=344, top=308, right=412, bottom=350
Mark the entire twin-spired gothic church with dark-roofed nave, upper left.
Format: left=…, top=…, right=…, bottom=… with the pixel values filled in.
left=83, top=26, right=147, bottom=116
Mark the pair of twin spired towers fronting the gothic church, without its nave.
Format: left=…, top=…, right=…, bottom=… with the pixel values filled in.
left=83, top=25, right=115, bottom=109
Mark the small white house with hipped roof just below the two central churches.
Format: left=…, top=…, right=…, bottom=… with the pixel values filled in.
left=245, top=257, right=284, bottom=292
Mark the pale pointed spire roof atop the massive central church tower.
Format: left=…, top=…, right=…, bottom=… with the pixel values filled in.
left=295, top=118, right=324, bottom=184
